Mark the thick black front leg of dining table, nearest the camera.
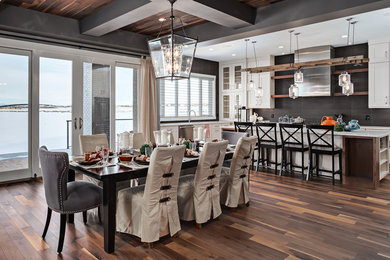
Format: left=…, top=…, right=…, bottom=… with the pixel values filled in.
left=103, top=180, right=116, bottom=253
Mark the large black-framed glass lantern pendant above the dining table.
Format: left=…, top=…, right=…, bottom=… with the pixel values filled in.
left=148, top=0, right=198, bottom=80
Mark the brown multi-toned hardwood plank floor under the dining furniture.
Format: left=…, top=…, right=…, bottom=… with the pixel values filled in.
left=0, top=173, right=390, bottom=260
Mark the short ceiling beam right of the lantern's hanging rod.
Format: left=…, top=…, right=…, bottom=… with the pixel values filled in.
left=174, top=0, right=256, bottom=28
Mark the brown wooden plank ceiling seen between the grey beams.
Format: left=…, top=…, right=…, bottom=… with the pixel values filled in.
left=4, top=0, right=283, bottom=36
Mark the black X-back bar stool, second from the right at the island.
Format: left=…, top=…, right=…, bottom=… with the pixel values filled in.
left=279, top=123, right=309, bottom=179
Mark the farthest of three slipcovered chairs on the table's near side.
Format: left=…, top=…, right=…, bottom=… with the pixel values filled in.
left=220, top=136, right=257, bottom=208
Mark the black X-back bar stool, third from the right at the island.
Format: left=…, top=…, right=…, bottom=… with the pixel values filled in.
left=256, top=123, right=282, bottom=174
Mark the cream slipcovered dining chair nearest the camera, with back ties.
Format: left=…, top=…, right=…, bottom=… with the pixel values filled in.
left=116, top=145, right=185, bottom=245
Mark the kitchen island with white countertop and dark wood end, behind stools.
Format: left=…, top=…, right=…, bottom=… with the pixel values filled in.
left=222, top=127, right=390, bottom=188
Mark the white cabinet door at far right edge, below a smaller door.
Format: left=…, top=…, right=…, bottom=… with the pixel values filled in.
left=368, top=62, right=390, bottom=108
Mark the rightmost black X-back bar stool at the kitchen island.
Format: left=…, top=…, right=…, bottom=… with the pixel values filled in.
left=306, top=125, right=343, bottom=185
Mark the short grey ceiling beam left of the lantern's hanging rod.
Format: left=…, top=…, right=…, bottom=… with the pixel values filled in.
left=80, top=0, right=170, bottom=36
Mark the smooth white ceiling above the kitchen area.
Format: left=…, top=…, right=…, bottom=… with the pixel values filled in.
left=196, top=8, right=390, bottom=62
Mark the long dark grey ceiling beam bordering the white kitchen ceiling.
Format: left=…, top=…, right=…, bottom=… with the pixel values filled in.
left=186, top=0, right=390, bottom=46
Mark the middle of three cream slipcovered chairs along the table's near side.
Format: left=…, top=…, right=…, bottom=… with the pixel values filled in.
left=177, top=140, right=228, bottom=228
